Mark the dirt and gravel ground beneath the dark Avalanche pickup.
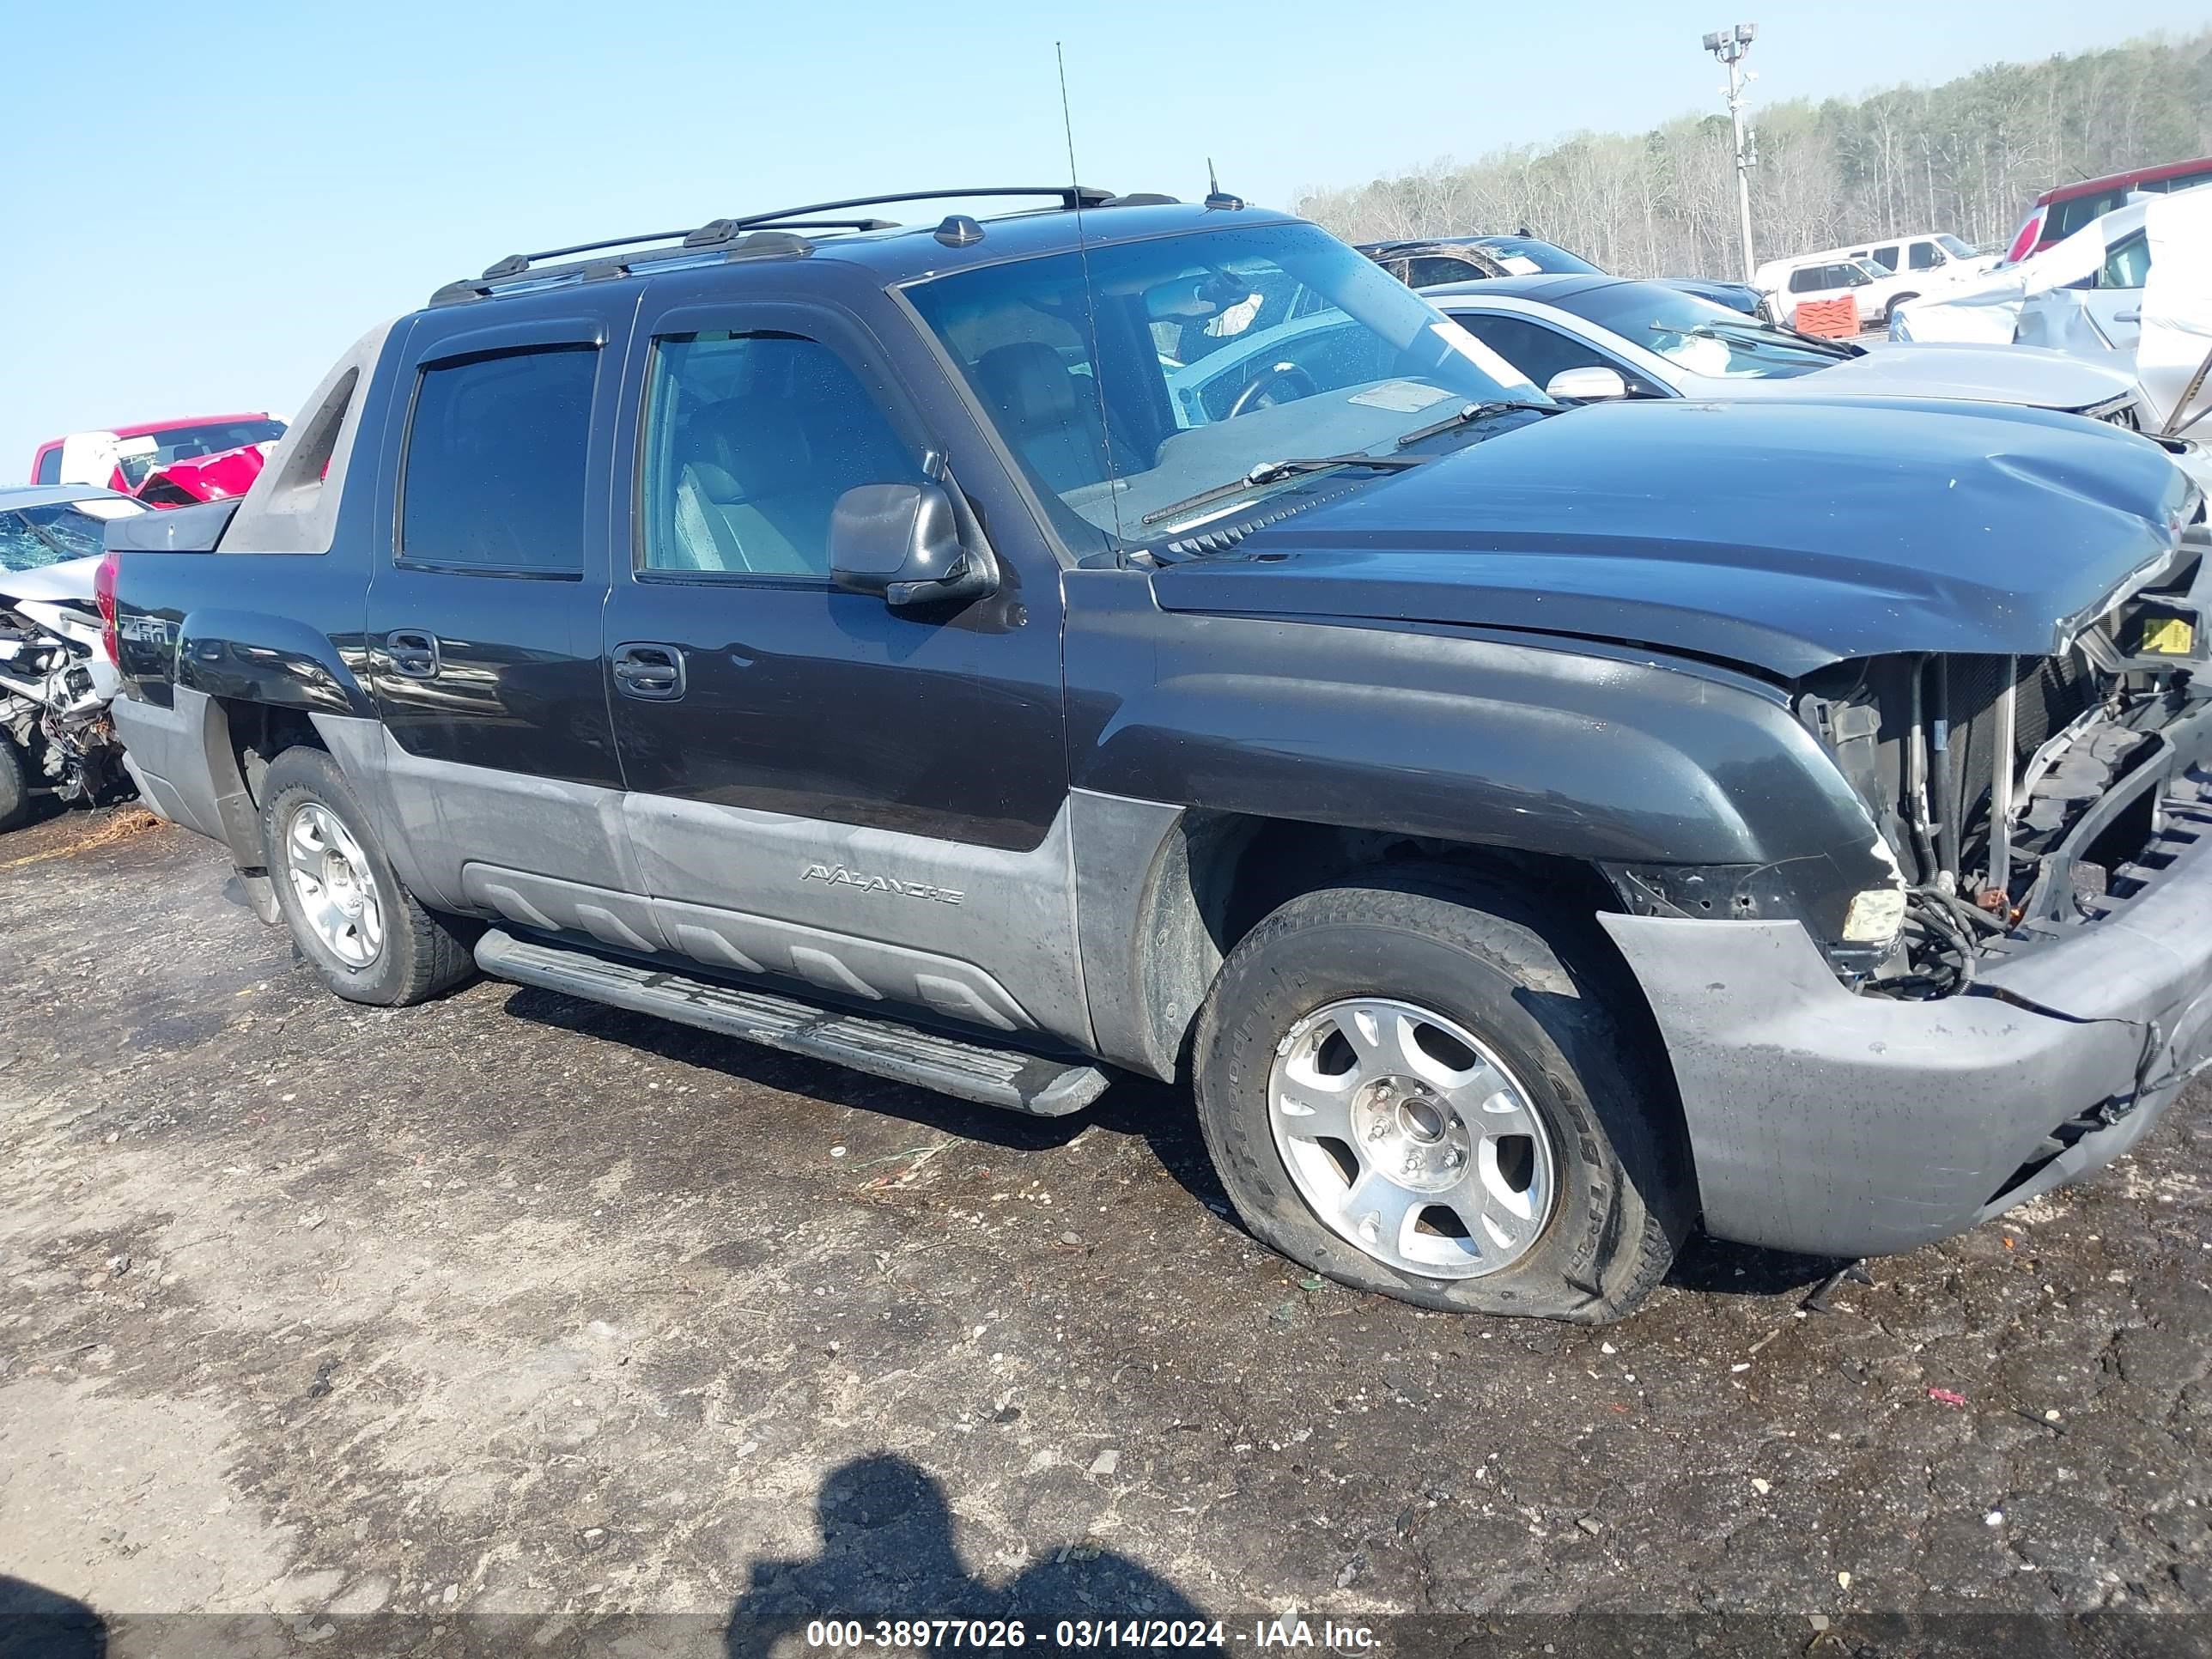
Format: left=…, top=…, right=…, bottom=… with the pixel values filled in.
left=0, top=810, right=2212, bottom=1655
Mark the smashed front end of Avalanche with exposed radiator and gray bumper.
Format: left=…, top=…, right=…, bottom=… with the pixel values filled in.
left=1604, top=517, right=2212, bottom=1256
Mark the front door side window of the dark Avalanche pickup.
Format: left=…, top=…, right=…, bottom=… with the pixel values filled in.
left=639, top=331, right=922, bottom=580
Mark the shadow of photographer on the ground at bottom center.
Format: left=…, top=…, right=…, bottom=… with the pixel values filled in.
left=726, top=1453, right=1207, bottom=1659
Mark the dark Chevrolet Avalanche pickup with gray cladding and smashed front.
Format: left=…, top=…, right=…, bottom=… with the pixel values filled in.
left=101, top=188, right=2212, bottom=1321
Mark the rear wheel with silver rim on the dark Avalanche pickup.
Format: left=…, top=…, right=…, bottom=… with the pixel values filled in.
left=261, top=748, right=473, bottom=1009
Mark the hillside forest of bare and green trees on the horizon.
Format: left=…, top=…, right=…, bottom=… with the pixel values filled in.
left=1298, top=28, right=2212, bottom=276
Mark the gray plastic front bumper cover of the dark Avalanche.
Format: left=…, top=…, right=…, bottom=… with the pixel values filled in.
left=1599, top=799, right=2212, bottom=1256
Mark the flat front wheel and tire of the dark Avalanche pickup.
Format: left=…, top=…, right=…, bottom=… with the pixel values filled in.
left=1197, top=869, right=1690, bottom=1322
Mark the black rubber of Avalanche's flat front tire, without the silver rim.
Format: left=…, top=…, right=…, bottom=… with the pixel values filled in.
left=1194, top=869, right=1690, bottom=1322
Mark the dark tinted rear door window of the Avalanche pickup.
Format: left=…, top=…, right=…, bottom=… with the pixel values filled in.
left=398, top=345, right=599, bottom=573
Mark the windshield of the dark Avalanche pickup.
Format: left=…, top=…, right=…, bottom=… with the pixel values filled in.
left=907, top=226, right=1547, bottom=546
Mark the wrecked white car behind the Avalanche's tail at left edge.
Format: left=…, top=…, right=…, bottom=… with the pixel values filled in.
left=0, top=484, right=146, bottom=830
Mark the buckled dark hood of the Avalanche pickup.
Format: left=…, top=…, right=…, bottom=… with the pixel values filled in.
left=1152, top=398, right=2199, bottom=679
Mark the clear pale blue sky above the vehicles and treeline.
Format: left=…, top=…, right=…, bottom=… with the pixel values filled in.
left=0, top=0, right=2212, bottom=480
